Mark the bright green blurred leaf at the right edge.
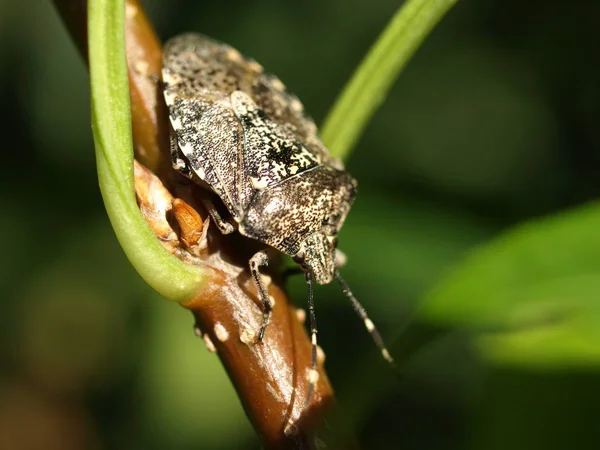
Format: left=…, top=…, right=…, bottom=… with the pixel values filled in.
left=421, top=203, right=600, bottom=368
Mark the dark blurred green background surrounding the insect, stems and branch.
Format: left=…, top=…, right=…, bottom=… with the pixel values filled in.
left=0, top=0, right=600, bottom=450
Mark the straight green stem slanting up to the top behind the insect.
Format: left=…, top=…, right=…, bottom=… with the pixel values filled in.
left=321, top=0, right=457, bottom=158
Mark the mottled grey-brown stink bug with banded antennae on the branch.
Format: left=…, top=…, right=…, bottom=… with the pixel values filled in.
left=162, top=34, right=393, bottom=403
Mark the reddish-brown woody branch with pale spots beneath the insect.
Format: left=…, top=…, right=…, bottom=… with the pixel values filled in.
left=54, top=0, right=357, bottom=449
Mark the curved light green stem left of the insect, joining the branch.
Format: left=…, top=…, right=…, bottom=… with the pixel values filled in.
left=88, top=0, right=205, bottom=302
